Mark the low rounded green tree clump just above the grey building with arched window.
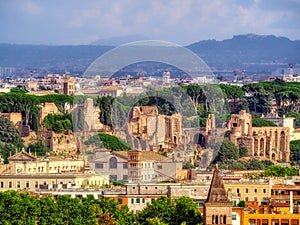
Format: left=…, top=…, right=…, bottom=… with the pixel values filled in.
left=84, top=134, right=130, bottom=151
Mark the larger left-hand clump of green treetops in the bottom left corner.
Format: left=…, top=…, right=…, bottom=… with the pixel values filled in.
left=0, top=191, right=134, bottom=225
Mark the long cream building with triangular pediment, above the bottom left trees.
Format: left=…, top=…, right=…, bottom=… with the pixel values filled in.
left=0, top=151, right=109, bottom=191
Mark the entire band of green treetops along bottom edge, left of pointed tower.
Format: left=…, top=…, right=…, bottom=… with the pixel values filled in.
left=0, top=191, right=202, bottom=225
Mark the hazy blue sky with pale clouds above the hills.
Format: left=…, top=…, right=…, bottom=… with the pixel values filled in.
left=0, top=0, right=300, bottom=45
